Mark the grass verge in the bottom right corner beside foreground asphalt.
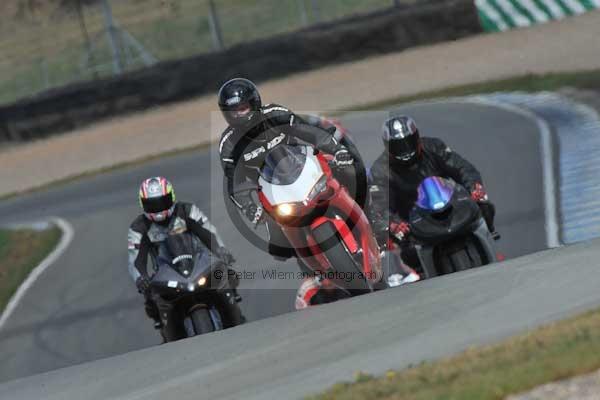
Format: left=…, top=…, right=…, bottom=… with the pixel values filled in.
left=310, top=309, right=600, bottom=400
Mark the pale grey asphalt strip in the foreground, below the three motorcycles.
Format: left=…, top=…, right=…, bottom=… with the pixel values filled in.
left=0, top=240, right=600, bottom=400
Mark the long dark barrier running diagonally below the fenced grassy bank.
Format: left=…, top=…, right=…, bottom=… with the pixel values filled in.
left=0, top=0, right=481, bottom=141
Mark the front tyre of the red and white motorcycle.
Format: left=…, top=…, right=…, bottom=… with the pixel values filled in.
left=313, top=222, right=371, bottom=296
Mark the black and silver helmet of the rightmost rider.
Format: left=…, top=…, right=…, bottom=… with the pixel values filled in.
left=383, top=116, right=421, bottom=165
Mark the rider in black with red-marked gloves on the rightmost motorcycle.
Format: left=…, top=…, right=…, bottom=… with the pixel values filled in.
left=369, top=116, right=495, bottom=269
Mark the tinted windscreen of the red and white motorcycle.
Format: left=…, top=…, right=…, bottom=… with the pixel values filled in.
left=260, top=145, right=306, bottom=185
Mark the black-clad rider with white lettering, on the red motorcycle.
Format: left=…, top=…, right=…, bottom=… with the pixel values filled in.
left=219, top=78, right=356, bottom=310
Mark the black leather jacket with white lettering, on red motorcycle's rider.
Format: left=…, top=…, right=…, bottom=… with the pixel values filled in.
left=219, top=104, right=341, bottom=208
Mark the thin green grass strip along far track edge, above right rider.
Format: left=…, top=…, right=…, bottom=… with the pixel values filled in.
left=340, top=70, right=600, bottom=113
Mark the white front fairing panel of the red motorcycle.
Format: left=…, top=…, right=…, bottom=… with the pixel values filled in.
left=258, top=148, right=323, bottom=206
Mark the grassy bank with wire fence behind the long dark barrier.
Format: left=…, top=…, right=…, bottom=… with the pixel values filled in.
left=0, top=0, right=418, bottom=103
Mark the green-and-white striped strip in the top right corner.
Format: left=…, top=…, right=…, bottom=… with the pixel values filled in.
left=475, top=0, right=600, bottom=32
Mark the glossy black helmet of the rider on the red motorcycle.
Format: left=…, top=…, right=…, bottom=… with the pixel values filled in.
left=219, top=78, right=262, bottom=128
